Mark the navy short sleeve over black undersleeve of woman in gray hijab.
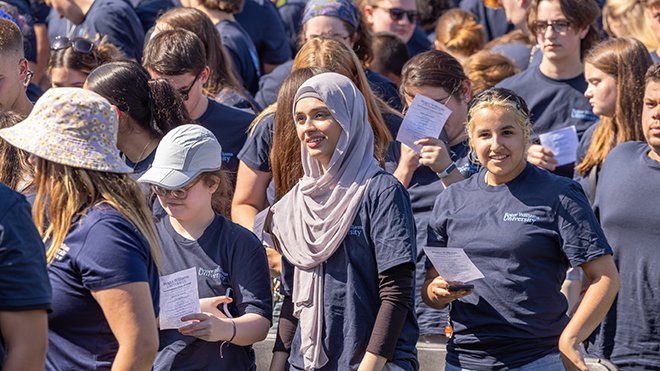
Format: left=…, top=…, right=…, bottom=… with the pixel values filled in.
left=369, top=183, right=417, bottom=273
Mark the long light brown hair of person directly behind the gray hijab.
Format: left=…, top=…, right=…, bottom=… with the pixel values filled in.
left=296, top=37, right=398, bottom=162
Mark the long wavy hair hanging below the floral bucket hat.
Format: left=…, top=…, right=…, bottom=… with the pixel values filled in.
left=32, top=159, right=159, bottom=265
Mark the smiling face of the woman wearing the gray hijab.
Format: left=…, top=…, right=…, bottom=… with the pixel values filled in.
left=293, top=97, right=342, bottom=169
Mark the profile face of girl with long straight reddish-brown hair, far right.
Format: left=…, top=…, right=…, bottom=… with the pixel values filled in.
left=584, top=63, right=617, bottom=117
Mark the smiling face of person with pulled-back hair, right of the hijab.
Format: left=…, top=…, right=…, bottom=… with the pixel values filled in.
left=470, top=107, right=527, bottom=185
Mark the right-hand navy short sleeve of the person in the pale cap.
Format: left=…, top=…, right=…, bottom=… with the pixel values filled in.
left=229, top=232, right=273, bottom=321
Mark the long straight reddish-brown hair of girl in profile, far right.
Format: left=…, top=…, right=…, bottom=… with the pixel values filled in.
left=575, top=38, right=652, bottom=175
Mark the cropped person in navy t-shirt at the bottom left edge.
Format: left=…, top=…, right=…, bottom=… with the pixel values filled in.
left=0, top=183, right=51, bottom=371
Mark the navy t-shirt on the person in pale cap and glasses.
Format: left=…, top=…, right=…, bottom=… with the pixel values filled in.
left=154, top=215, right=272, bottom=371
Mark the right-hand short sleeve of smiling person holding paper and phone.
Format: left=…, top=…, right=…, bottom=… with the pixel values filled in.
left=557, top=183, right=613, bottom=267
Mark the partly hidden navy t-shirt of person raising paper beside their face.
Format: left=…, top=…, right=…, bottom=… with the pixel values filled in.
left=385, top=141, right=479, bottom=336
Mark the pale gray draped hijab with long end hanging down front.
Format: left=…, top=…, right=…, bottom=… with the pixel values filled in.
left=271, top=72, right=380, bottom=370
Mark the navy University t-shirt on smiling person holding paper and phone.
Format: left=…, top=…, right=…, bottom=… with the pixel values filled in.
left=429, top=164, right=612, bottom=370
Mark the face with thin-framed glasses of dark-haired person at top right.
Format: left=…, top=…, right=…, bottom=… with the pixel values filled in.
left=536, top=0, right=589, bottom=63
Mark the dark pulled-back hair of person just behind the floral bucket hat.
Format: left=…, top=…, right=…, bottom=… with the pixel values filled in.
left=86, top=62, right=194, bottom=138
